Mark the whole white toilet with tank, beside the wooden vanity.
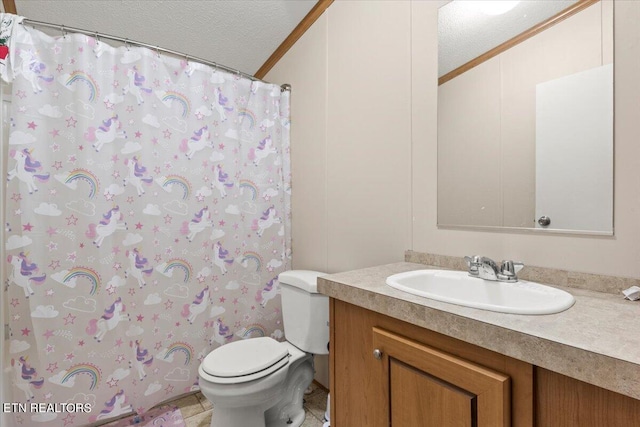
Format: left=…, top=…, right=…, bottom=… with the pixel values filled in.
left=198, top=270, right=329, bottom=427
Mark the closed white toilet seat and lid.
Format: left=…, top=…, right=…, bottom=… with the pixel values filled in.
left=201, top=337, right=289, bottom=384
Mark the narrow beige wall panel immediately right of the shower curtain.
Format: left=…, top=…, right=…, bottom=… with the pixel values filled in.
left=266, top=7, right=329, bottom=272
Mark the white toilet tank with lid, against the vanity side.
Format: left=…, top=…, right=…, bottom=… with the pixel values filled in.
left=278, top=270, right=329, bottom=354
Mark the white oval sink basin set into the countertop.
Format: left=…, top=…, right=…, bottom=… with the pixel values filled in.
left=387, top=270, right=575, bottom=314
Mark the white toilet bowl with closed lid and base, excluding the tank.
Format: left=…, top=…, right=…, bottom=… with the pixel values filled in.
left=198, top=337, right=313, bottom=427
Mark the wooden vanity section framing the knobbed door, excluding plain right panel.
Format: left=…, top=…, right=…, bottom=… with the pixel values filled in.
left=330, top=299, right=533, bottom=427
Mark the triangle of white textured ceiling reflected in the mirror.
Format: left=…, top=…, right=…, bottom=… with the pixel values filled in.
left=438, top=0, right=577, bottom=77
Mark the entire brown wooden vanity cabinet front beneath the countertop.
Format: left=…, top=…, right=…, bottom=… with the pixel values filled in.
left=329, top=296, right=640, bottom=427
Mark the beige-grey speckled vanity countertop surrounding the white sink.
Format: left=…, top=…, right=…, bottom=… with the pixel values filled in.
left=318, top=262, right=640, bottom=399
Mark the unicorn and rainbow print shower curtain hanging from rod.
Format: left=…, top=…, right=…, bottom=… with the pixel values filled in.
left=0, top=15, right=291, bottom=426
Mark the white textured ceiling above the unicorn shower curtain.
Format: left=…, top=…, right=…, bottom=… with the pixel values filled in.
left=15, top=0, right=316, bottom=75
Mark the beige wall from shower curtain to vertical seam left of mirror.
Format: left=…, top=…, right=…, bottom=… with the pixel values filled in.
left=266, top=1, right=412, bottom=272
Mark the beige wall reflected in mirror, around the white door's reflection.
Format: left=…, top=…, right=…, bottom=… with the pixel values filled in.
left=438, top=2, right=613, bottom=228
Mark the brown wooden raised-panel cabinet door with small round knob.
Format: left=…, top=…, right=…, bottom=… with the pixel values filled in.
left=372, top=327, right=511, bottom=427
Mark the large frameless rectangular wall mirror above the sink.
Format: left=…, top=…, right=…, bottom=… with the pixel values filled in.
left=438, top=0, right=613, bottom=235
